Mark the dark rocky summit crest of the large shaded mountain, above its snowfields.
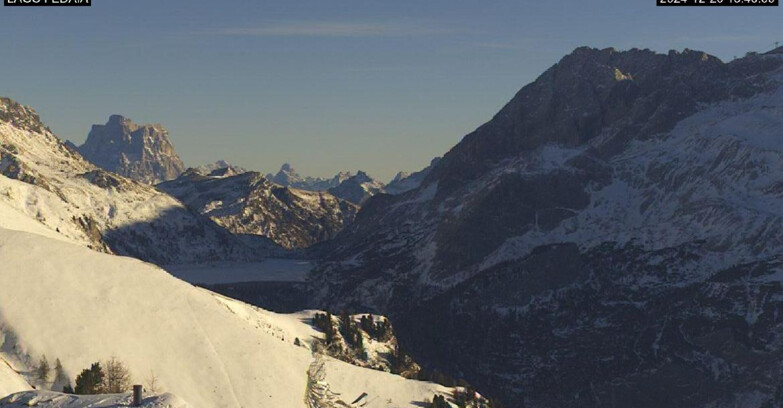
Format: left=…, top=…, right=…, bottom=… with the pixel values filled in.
left=425, top=47, right=775, bottom=192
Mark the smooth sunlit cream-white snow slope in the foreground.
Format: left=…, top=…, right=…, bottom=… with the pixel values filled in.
left=0, top=229, right=448, bottom=408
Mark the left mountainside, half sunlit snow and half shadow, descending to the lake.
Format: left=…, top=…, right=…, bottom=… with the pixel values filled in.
left=0, top=98, right=251, bottom=264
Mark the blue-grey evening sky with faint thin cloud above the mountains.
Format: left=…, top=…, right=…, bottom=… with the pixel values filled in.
left=0, top=0, right=783, bottom=180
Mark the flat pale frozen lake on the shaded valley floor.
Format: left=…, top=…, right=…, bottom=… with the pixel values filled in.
left=163, top=258, right=315, bottom=285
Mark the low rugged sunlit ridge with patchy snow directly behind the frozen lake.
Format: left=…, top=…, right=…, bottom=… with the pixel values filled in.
left=158, top=168, right=358, bottom=249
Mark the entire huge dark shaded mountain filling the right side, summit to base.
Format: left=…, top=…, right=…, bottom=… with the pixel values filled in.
left=312, top=48, right=783, bottom=408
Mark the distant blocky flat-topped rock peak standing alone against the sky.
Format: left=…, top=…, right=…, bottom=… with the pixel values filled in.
left=78, top=115, right=185, bottom=184
